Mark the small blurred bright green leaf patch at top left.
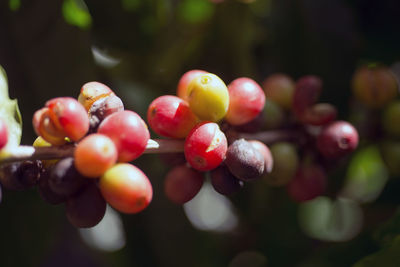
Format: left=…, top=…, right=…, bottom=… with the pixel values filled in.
left=62, top=0, right=92, bottom=29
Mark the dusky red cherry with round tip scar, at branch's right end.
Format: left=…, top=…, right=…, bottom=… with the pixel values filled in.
left=317, top=121, right=358, bottom=158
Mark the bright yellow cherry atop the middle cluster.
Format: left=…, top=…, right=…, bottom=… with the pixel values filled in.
left=188, top=73, right=229, bottom=122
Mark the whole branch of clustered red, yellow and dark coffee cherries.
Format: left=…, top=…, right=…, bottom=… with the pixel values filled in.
left=0, top=66, right=368, bottom=227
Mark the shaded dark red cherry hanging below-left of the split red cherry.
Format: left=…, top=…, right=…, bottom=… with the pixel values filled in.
left=164, top=164, right=204, bottom=204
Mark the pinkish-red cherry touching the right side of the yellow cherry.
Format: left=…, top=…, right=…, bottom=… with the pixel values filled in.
left=225, top=78, right=265, bottom=125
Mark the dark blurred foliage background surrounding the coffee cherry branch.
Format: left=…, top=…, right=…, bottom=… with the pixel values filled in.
left=0, top=0, right=400, bottom=267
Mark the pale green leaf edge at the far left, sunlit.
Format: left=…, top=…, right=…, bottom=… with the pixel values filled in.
left=0, top=66, right=22, bottom=157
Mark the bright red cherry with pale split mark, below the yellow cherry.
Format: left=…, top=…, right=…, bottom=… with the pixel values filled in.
left=184, top=122, right=228, bottom=171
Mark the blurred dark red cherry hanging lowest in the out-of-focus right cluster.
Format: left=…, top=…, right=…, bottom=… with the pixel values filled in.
left=287, top=165, right=327, bottom=202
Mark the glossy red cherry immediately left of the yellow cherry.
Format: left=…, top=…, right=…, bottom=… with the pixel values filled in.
left=147, top=95, right=198, bottom=138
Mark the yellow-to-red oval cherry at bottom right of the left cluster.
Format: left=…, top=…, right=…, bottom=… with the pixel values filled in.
left=99, top=163, right=153, bottom=213
